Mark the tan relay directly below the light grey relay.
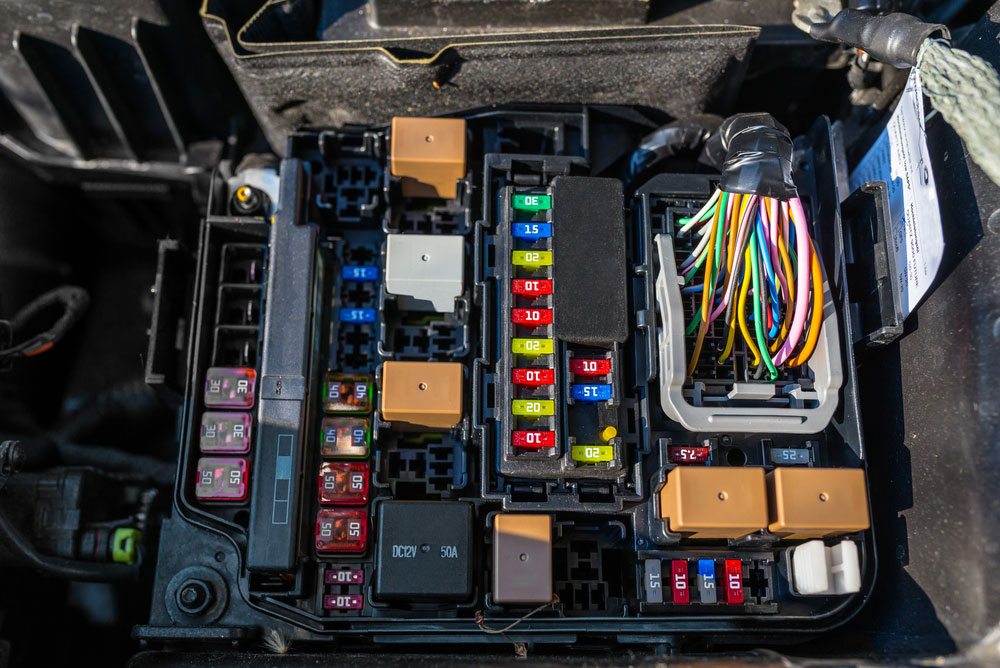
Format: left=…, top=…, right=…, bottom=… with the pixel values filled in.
left=381, top=362, right=463, bottom=429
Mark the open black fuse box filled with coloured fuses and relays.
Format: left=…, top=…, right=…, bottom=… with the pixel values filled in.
left=137, top=105, right=876, bottom=645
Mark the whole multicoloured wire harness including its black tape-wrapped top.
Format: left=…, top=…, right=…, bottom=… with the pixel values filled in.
left=678, top=114, right=823, bottom=381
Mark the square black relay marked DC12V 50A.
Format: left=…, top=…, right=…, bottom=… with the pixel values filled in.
left=375, top=501, right=472, bottom=601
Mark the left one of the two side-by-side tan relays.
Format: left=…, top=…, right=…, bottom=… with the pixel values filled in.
left=660, top=466, right=767, bottom=538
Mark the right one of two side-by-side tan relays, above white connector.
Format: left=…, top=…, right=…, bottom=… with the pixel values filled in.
left=767, top=466, right=868, bottom=539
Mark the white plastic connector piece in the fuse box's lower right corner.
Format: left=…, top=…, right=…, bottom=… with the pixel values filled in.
left=788, top=540, right=861, bottom=596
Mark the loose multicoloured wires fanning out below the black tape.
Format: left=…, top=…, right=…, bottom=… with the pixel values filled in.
left=678, top=190, right=823, bottom=380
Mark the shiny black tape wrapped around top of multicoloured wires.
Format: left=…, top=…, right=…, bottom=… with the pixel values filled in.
left=719, top=113, right=798, bottom=199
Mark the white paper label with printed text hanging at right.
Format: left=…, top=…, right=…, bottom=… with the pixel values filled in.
left=850, top=68, right=944, bottom=317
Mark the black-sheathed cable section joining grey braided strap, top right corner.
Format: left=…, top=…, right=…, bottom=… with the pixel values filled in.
left=809, top=9, right=951, bottom=68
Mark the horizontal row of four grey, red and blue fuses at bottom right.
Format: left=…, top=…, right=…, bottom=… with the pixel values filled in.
left=643, top=559, right=744, bottom=605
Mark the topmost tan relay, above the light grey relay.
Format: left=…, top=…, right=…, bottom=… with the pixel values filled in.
left=389, top=116, right=465, bottom=199
